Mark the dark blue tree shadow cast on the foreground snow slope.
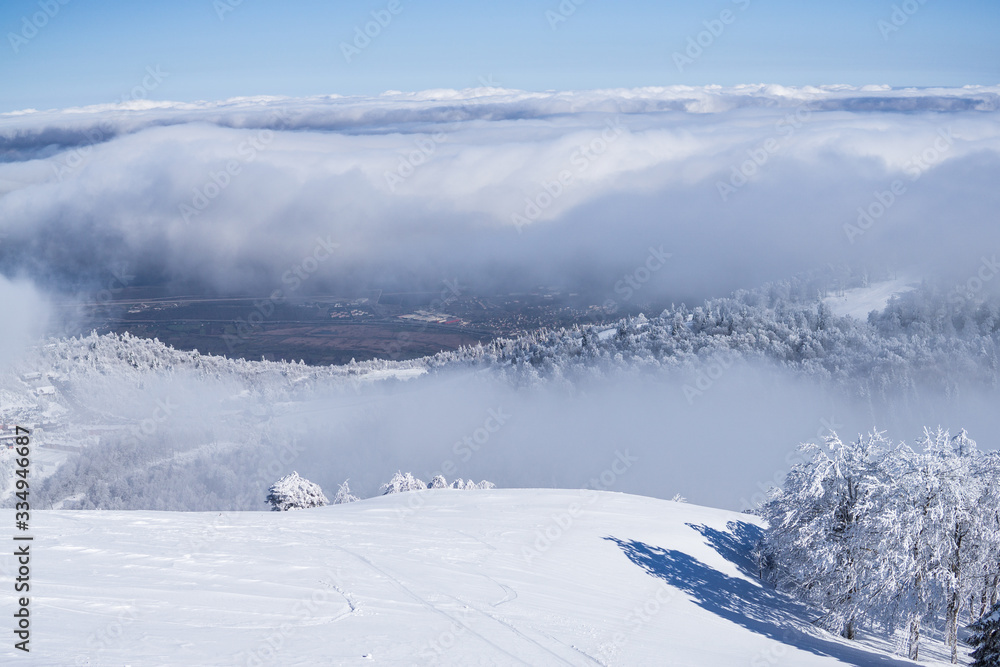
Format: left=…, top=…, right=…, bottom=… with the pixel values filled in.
left=604, top=521, right=913, bottom=667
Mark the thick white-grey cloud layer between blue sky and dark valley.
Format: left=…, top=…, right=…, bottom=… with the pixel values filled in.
left=0, top=85, right=1000, bottom=302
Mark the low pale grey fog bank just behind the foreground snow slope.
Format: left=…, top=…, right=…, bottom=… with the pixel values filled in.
left=278, top=365, right=1000, bottom=510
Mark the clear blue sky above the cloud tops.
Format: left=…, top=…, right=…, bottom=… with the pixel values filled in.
left=0, top=0, right=1000, bottom=111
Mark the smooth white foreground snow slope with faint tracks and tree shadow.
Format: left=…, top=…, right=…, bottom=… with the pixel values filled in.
left=0, top=489, right=960, bottom=667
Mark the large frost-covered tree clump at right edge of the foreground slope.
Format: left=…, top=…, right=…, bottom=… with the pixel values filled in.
left=761, top=428, right=1000, bottom=663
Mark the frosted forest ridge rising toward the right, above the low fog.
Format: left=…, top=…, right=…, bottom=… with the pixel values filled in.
left=430, top=281, right=1000, bottom=396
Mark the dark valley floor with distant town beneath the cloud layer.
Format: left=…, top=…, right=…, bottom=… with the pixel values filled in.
left=60, top=285, right=663, bottom=364
